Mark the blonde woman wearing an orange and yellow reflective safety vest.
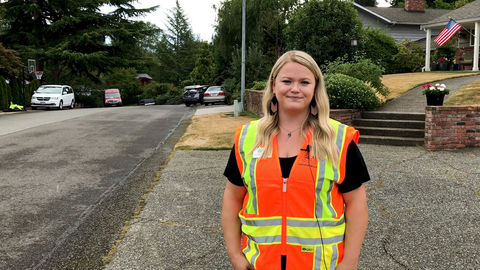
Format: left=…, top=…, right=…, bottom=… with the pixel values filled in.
left=222, top=51, right=369, bottom=270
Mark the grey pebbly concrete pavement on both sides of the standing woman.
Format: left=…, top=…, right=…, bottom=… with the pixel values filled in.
left=106, top=145, right=480, bottom=269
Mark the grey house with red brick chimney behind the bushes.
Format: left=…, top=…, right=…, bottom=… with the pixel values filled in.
left=353, top=0, right=451, bottom=43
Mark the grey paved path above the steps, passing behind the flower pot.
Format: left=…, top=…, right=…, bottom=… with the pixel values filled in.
left=377, top=75, right=480, bottom=112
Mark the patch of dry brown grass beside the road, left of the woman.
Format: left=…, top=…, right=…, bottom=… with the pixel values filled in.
left=175, top=113, right=255, bottom=150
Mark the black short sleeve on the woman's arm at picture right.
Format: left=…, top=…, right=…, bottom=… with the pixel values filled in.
left=338, top=141, right=370, bottom=193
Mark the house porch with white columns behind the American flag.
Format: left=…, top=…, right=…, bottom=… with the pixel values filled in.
left=421, top=0, right=480, bottom=71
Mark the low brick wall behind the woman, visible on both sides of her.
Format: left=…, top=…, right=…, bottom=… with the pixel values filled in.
left=246, top=90, right=361, bottom=126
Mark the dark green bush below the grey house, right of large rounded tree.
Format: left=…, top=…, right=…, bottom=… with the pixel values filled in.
left=360, top=27, right=398, bottom=74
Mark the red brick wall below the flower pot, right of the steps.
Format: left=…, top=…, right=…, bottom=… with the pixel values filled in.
left=425, top=106, right=480, bottom=150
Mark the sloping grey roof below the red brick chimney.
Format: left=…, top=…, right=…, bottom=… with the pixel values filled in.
left=353, top=0, right=450, bottom=25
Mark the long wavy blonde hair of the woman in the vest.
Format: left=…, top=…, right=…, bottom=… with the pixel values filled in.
left=253, top=51, right=339, bottom=166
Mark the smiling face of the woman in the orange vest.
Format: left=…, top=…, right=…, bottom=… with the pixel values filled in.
left=272, top=62, right=316, bottom=113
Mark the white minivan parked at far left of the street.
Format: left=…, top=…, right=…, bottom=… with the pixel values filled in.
left=31, top=85, right=75, bottom=110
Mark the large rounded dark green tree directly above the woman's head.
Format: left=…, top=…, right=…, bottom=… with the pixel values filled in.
left=285, top=0, right=363, bottom=65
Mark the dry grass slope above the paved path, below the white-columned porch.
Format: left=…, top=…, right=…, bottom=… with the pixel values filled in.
left=382, top=72, right=478, bottom=100
